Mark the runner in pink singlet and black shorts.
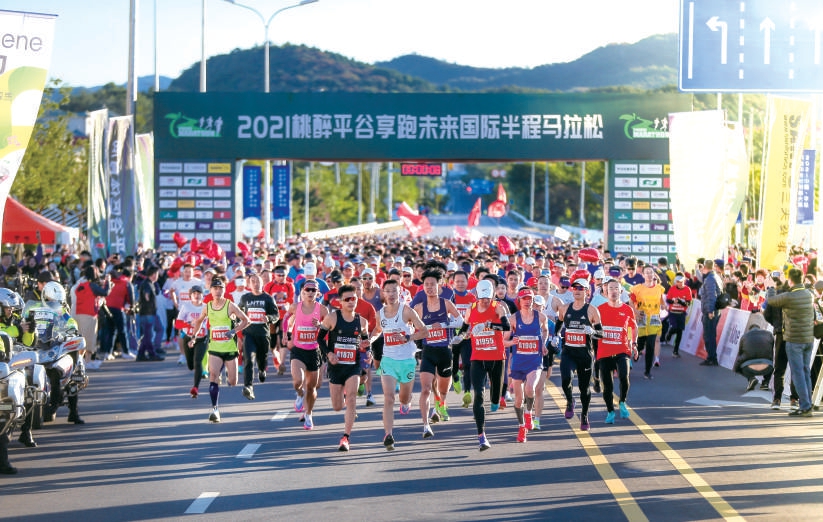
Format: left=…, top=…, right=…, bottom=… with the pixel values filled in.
left=286, top=281, right=328, bottom=430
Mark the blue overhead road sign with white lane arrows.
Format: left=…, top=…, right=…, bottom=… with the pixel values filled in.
left=679, top=0, right=823, bottom=92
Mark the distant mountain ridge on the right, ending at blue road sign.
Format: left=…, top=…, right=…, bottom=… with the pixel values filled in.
left=375, top=34, right=677, bottom=91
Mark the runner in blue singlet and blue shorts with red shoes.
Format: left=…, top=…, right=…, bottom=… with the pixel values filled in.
left=504, top=287, right=549, bottom=442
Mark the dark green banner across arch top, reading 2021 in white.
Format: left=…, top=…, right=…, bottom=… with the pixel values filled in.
left=154, top=92, right=691, bottom=162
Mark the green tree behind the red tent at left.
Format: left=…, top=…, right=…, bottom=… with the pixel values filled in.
left=11, top=80, right=88, bottom=215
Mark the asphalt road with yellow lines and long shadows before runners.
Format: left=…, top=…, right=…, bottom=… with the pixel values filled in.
left=0, top=340, right=823, bottom=521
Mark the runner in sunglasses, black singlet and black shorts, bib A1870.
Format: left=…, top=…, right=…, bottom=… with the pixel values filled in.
left=317, top=285, right=371, bottom=451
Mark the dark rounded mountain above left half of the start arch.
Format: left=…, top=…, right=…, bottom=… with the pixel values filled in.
left=168, top=44, right=438, bottom=92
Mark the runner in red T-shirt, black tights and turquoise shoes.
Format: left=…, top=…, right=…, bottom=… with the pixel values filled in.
left=597, top=278, right=637, bottom=424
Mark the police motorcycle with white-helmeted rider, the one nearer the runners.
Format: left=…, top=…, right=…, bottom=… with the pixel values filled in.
left=24, top=281, right=89, bottom=424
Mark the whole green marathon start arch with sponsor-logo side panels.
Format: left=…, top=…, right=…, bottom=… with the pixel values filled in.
left=154, top=92, right=691, bottom=259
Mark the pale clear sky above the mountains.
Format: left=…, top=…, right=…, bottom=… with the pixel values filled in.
left=0, top=0, right=679, bottom=86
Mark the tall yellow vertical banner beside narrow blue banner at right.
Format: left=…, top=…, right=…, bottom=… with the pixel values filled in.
left=758, top=97, right=811, bottom=270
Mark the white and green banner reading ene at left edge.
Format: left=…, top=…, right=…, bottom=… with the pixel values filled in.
left=0, top=11, right=56, bottom=242
